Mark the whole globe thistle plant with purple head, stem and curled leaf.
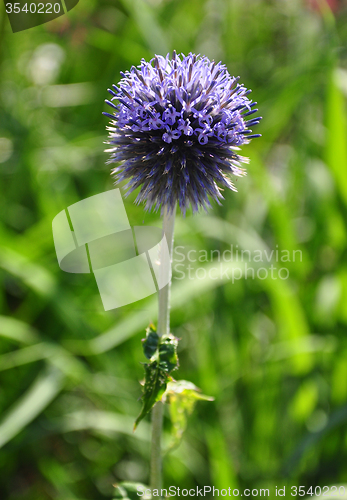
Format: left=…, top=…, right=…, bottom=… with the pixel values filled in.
left=103, top=51, right=261, bottom=491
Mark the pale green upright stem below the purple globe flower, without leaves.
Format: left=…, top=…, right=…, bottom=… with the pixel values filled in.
left=150, top=207, right=176, bottom=491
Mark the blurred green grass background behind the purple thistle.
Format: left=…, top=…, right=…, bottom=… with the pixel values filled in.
left=0, top=0, right=347, bottom=500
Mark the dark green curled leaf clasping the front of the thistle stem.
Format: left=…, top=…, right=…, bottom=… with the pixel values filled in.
left=134, top=325, right=178, bottom=430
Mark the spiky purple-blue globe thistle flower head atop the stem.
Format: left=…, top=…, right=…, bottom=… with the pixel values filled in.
left=103, top=52, right=261, bottom=213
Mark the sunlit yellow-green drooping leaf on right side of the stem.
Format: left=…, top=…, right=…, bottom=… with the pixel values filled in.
left=163, top=380, right=214, bottom=451
